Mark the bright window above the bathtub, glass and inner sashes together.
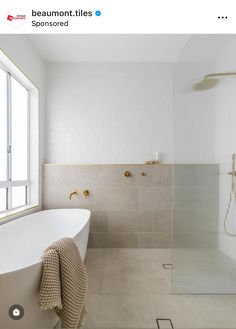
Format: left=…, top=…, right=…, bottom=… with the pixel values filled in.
left=0, top=67, right=30, bottom=212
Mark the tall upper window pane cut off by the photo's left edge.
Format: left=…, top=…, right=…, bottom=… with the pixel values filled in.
left=0, top=68, right=7, bottom=181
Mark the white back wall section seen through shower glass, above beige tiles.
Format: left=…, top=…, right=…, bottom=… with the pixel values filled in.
left=173, top=60, right=215, bottom=164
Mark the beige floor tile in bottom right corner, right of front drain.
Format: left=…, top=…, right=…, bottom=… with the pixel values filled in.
left=152, top=295, right=236, bottom=329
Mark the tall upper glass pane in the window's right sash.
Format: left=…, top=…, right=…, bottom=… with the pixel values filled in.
left=11, top=78, right=28, bottom=180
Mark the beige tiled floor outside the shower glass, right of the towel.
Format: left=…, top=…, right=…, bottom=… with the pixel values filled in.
left=86, top=249, right=236, bottom=329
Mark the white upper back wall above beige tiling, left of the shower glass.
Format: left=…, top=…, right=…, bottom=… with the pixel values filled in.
left=46, top=63, right=173, bottom=163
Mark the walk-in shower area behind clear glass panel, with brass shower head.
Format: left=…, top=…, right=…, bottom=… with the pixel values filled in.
left=172, top=35, right=236, bottom=294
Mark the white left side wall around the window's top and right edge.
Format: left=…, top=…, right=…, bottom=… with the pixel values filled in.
left=0, top=34, right=45, bottom=204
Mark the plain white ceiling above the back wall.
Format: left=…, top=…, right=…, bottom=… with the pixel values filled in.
left=28, top=34, right=191, bottom=62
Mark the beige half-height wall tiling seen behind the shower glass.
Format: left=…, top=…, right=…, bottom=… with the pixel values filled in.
left=173, top=164, right=219, bottom=248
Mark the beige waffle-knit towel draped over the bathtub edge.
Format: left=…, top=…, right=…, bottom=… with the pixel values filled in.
left=40, top=238, right=88, bottom=329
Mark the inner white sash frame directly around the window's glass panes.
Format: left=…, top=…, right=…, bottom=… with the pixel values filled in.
left=0, top=70, right=30, bottom=212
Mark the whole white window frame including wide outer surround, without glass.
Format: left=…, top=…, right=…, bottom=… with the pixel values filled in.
left=0, top=49, right=41, bottom=220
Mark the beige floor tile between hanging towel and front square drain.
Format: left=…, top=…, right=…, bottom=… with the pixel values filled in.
left=86, top=295, right=155, bottom=329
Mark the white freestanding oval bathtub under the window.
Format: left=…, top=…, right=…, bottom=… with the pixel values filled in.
left=0, top=209, right=90, bottom=329
